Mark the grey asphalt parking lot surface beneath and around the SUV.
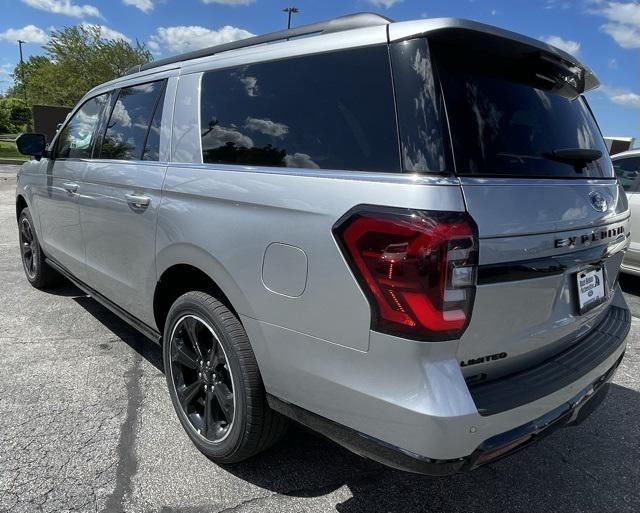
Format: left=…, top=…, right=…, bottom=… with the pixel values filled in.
left=0, top=166, right=640, bottom=513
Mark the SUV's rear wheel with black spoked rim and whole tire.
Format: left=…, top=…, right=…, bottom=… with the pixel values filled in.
left=163, top=291, right=287, bottom=463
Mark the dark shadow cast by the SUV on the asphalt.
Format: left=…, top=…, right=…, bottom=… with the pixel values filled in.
left=42, top=286, right=640, bottom=513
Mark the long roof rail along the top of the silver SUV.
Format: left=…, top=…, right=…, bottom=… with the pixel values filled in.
left=125, top=12, right=393, bottom=75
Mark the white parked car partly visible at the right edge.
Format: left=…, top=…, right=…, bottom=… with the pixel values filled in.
left=611, top=149, right=640, bottom=276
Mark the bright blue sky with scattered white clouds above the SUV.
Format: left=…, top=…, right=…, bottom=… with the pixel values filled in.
left=0, top=0, right=640, bottom=145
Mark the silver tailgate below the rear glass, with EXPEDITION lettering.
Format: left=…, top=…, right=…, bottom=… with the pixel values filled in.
left=459, top=179, right=629, bottom=380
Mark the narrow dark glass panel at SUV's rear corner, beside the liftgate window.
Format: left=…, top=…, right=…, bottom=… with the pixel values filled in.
left=391, top=38, right=452, bottom=173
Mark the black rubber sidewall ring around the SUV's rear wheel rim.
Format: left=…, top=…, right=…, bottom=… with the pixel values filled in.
left=163, top=293, right=247, bottom=460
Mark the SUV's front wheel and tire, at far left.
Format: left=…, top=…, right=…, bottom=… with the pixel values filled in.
left=18, top=208, right=61, bottom=289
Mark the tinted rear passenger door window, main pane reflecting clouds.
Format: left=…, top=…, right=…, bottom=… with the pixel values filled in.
left=100, top=81, right=164, bottom=160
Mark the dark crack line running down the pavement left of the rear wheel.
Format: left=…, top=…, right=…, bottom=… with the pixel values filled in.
left=104, top=355, right=142, bottom=513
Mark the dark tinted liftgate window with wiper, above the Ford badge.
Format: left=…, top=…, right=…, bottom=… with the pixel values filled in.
left=431, top=39, right=613, bottom=178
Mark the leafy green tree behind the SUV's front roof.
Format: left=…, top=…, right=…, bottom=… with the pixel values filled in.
left=8, top=25, right=152, bottom=107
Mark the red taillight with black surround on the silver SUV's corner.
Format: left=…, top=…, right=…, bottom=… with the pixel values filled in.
left=334, top=207, right=477, bottom=340
